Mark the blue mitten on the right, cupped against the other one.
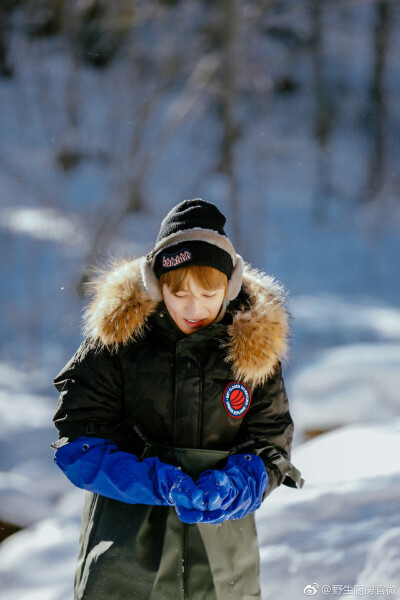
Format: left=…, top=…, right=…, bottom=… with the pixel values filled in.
left=177, top=454, right=268, bottom=523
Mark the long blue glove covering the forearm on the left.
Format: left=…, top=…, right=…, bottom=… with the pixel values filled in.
left=54, top=437, right=203, bottom=509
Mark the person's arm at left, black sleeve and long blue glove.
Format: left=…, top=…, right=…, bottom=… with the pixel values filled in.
left=52, top=339, right=205, bottom=506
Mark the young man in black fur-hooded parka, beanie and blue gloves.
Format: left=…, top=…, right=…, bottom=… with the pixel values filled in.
left=54, top=199, right=302, bottom=600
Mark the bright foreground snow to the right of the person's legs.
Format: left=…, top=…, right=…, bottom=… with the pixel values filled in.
left=257, top=419, right=400, bottom=600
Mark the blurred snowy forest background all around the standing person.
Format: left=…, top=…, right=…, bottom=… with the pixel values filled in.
left=0, top=0, right=400, bottom=600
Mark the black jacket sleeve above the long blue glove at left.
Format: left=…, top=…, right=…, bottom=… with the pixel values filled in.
left=53, top=339, right=123, bottom=448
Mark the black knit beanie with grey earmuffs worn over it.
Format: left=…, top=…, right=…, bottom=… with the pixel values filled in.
left=142, top=198, right=243, bottom=300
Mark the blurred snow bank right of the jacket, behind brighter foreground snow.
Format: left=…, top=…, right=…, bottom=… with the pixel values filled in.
left=291, top=343, right=400, bottom=431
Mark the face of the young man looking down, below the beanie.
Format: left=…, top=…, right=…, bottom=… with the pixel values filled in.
left=162, top=277, right=225, bottom=335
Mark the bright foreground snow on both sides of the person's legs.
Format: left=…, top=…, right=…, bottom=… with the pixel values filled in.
left=0, top=419, right=400, bottom=600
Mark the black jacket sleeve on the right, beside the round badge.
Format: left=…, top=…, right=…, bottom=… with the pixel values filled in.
left=234, top=363, right=304, bottom=498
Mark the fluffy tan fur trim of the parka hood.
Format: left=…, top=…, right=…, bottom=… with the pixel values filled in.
left=83, top=259, right=289, bottom=386
